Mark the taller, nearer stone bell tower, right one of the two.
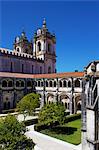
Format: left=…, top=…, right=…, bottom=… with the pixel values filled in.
left=33, top=19, right=56, bottom=73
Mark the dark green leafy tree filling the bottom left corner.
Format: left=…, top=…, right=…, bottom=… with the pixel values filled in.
left=0, top=115, right=34, bottom=150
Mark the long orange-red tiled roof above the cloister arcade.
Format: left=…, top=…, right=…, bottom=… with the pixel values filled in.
left=0, top=72, right=84, bottom=78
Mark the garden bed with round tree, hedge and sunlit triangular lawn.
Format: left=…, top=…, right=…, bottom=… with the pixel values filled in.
left=35, top=104, right=81, bottom=145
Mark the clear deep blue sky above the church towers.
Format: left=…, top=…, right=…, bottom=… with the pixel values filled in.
left=0, top=0, right=99, bottom=72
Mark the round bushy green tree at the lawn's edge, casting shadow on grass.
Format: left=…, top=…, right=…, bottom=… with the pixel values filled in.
left=38, top=103, right=65, bottom=128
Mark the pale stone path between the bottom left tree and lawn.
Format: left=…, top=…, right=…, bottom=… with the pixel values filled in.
left=26, top=125, right=81, bottom=150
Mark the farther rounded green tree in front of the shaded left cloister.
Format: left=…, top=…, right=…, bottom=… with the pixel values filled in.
left=17, top=93, right=40, bottom=120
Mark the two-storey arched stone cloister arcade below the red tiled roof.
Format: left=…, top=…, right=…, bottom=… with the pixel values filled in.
left=0, top=78, right=82, bottom=113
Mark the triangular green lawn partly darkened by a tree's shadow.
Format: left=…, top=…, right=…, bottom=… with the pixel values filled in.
left=40, top=119, right=81, bottom=145
